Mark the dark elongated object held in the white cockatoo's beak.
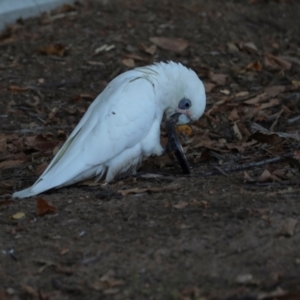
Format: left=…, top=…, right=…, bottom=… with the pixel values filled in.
left=165, top=113, right=191, bottom=174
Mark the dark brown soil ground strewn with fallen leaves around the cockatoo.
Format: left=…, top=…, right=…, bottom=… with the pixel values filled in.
left=0, top=0, right=300, bottom=300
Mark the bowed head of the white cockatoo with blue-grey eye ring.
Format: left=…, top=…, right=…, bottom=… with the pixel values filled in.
left=165, top=64, right=206, bottom=125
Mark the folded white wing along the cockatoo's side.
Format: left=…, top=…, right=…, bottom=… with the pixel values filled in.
left=38, top=77, right=157, bottom=184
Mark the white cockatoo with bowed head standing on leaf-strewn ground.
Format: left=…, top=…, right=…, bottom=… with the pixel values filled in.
left=13, top=62, right=206, bottom=198
